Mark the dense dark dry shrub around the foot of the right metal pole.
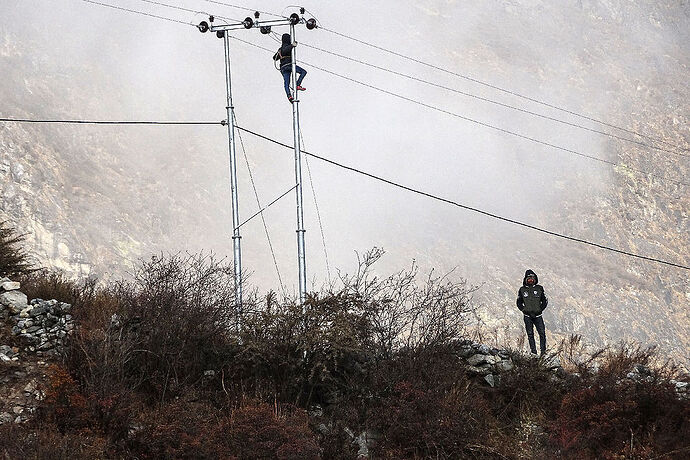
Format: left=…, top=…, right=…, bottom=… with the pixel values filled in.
left=236, top=294, right=373, bottom=406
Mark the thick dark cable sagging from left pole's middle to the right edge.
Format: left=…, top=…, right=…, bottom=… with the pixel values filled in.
left=236, top=126, right=690, bottom=270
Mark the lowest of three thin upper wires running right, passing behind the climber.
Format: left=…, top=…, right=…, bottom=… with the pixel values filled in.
left=231, top=36, right=690, bottom=186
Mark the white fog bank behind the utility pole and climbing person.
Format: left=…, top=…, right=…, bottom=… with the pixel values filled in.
left=0, top=0, right=690, bottom=330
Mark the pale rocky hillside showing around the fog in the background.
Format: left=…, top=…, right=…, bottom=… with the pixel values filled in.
left=0, top=0, right=690, bottom=361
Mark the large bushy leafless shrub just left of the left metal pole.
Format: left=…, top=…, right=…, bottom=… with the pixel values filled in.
left=68, top=254, right=235, bottom=401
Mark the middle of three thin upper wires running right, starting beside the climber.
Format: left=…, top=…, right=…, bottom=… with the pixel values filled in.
left=300, top=42, right=689, bottom=157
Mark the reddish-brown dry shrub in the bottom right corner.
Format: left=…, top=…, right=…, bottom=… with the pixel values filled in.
left=553, top=344, right=690, bottom=459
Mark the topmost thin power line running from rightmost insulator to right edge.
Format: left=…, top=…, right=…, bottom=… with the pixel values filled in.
left=319, top=27, right=690, bottom=151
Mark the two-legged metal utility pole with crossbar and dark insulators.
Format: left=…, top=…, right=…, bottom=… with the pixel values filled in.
left=197, top=8, right=316, bottom=310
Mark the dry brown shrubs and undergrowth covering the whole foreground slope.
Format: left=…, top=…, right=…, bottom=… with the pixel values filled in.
left=0, top=252, right=690, bottom=459
